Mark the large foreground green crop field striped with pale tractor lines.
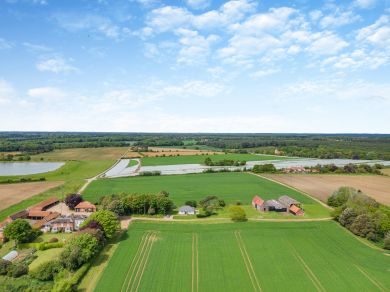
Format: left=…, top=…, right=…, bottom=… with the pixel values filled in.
left=95, top=221, right=390, bottom=291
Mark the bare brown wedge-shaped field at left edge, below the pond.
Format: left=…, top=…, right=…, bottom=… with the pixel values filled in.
left=0, top=181, right=64, bottom=210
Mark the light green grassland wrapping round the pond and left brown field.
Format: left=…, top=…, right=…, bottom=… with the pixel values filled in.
left=0, top=160, right=114, bottom=221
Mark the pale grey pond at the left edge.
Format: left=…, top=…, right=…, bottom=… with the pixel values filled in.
left=0, top=162, right=65, bottom=176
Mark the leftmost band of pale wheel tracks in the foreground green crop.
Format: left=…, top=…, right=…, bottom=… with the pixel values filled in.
left=121, top=232, right=156, bottom=292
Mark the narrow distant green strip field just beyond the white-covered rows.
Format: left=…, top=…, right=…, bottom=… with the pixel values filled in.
left=141, top=153, right=288, bottom=166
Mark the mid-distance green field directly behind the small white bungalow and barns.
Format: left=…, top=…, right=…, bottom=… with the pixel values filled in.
left=83, top=173, right=329, bottom=217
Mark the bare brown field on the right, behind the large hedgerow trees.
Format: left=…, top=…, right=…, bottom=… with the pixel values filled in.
left=264, top=174, right=390, bottom=205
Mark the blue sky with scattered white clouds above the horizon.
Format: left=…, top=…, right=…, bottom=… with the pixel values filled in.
left=0, top=0, right=390, bottom=133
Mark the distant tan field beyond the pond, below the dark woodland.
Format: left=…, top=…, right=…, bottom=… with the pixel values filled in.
left=32, top=147, right=134, bottom=161
